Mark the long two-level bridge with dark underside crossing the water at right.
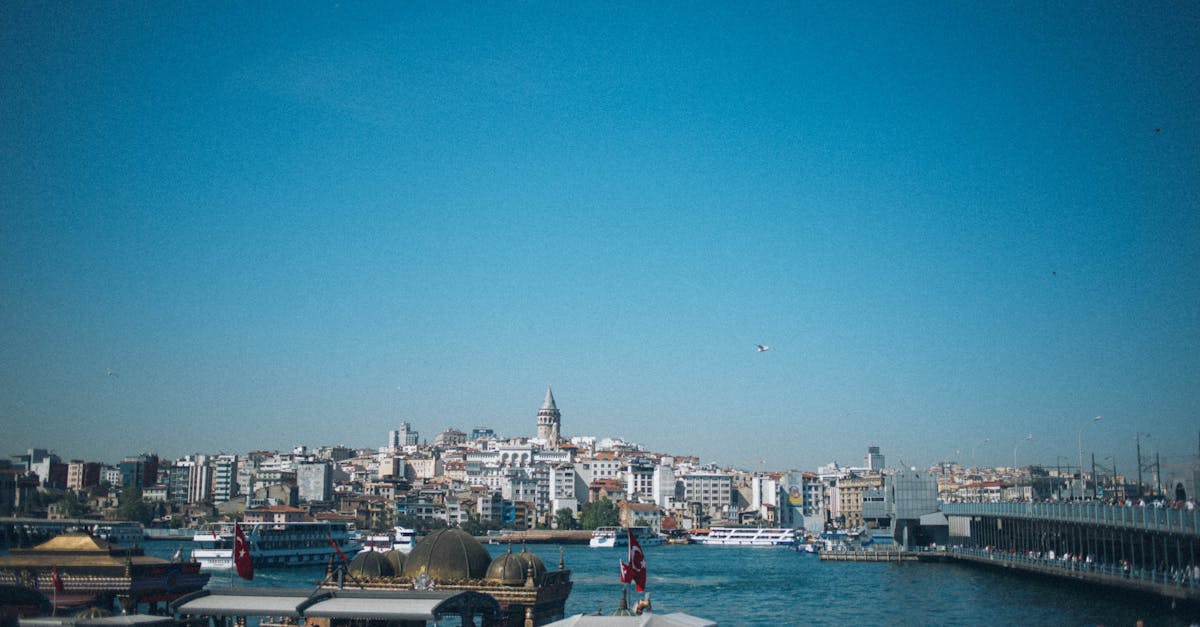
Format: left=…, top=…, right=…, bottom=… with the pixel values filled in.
left=941, top=502, right=1200, bottom=602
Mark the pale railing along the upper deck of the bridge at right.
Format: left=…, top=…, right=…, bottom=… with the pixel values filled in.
left=940, top=502, right=1200, bottom=536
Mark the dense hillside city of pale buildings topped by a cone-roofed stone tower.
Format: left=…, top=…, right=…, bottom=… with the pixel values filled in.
left=0, top=387, right=1194, bottom=535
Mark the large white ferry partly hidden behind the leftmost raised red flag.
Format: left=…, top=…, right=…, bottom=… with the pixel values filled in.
left=192, top=523, right=362, bottom=569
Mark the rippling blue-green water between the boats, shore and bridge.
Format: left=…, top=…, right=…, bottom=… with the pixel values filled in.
left=148, top=543, right=1200, bottom=627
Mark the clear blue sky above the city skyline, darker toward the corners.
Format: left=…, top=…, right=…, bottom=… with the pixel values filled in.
left=0, top=1, right=1200, bottom=473
